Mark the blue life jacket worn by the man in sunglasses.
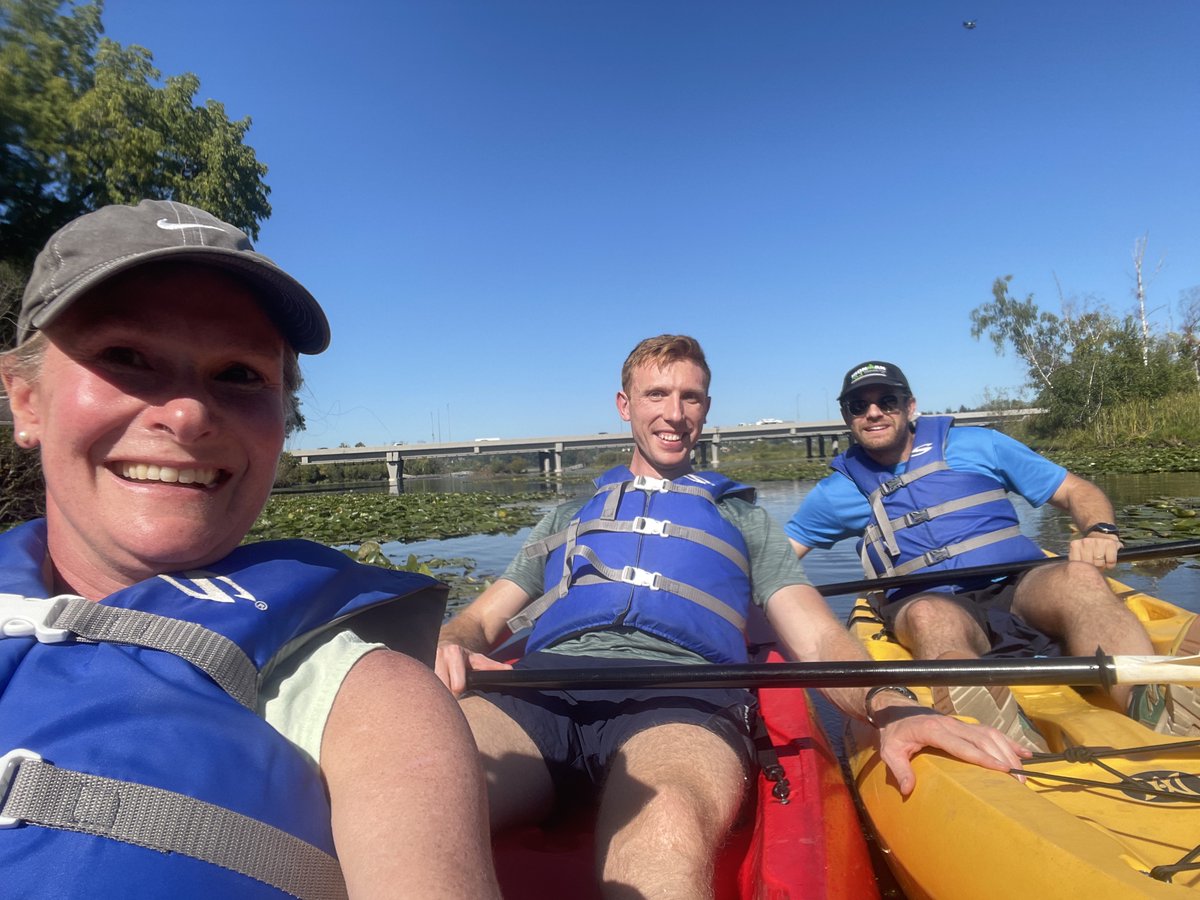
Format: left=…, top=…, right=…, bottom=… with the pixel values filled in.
left=830, top=415, right=1042, bottom=599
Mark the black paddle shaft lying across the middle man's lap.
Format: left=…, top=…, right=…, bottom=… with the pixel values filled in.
left=467, top=654, right=1123, bottom=690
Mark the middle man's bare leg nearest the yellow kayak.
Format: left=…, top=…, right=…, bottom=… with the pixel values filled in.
left=596, top=725, right=746, bottom=900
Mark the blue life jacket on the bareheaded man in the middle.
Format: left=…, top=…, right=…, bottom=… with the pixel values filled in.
left=509, top=466, right=754, bottom=662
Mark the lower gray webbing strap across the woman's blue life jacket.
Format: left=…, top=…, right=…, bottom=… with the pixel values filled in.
left=0, top=750, right=347, bottom=900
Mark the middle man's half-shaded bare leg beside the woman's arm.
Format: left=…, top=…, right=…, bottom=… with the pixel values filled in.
left=460, top=697, right=554, bottom=834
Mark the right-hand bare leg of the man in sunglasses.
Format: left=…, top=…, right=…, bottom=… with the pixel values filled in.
left=1013, top=562, right=1154, bottom=709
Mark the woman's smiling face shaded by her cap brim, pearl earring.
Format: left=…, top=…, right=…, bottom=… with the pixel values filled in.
left=7, top=265, right=289, bottom=599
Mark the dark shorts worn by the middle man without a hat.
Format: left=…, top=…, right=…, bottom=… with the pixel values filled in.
left=463, top=652, right=758, bottom=798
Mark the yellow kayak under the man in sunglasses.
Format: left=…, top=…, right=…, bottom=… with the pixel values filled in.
left=846, top=582, right=1200, bottom=900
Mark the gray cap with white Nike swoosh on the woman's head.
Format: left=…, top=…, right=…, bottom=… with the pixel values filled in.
left=17, top=200, right=329, bottom=354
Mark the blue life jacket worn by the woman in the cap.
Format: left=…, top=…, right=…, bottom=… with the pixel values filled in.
left=0, top=521, right=445, bottom=900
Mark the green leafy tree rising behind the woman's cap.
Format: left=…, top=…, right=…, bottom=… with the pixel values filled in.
left=0, top=0, right=271, bottom=524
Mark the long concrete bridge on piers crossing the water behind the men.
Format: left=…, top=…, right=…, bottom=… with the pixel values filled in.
left=289, top=409, right=1040, bottom=488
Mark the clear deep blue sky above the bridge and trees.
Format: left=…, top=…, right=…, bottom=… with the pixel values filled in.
left=96, top=0, right=1200, bottom=448
